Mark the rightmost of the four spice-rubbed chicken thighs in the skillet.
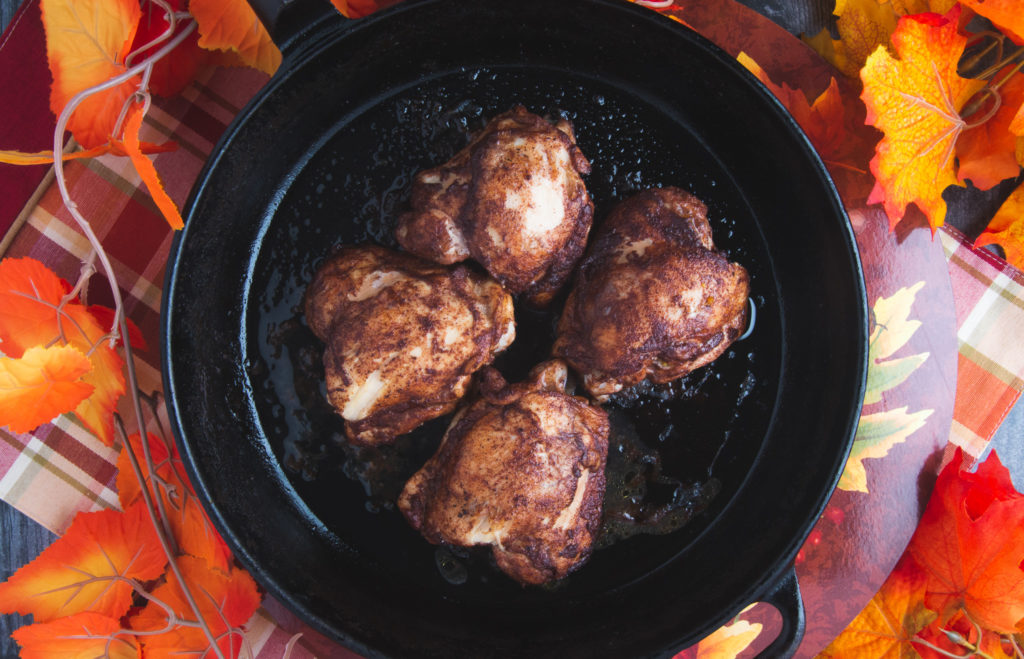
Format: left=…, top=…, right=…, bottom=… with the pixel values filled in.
left=553, top=187, right=750, bottom=401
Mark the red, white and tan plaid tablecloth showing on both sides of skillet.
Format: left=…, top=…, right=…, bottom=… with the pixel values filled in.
left=0, top=0, right=1024, bottom=657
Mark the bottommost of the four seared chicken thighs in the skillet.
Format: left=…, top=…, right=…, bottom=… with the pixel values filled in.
left=398, top=361, right=608, bottom=583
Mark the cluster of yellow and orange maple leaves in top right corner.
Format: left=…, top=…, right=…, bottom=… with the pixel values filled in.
left=806, top=0, right=1024, bottom=259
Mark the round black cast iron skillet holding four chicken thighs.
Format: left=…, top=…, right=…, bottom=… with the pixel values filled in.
left=163, top=0, right=866, bottom=657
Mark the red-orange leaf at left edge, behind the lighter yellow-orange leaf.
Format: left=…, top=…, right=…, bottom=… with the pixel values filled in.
left=0, top=258, right=125, bottom=446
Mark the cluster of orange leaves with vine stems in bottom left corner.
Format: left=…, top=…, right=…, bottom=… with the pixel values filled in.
left=0, top=434, right=262, bottom=659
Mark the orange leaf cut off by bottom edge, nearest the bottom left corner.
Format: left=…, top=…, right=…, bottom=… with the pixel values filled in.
left=10, top=611, right=139, bottom=659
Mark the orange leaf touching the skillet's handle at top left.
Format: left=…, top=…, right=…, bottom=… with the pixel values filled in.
left=188, top=0, right=281, bottom=75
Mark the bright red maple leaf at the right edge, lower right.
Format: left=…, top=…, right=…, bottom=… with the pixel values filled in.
left=907, top=449, right=1024, bottom=633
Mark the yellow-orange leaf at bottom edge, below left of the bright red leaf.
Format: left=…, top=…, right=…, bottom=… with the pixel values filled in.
left=818, top=556, right=935, bottom=659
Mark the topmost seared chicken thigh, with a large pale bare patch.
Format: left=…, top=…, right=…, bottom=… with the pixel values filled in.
left=395, top=106, right=594, bottom=306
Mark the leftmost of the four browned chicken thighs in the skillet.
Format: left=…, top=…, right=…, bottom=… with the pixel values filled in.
left=305, top=246, right=515, bottom=444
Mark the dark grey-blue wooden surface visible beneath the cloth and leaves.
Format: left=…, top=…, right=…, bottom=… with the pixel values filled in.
left=0, top=0, right=1024, bottom=658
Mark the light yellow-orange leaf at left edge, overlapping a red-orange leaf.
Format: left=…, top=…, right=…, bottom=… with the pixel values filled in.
left=0, top=346, right=95, bottom=433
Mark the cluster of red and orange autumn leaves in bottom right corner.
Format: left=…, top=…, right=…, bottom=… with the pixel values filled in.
left=820, top=450, right=1024, bottom=659
